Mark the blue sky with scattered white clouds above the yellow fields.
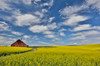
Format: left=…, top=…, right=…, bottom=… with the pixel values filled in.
left=0, top=0, right=100, bottom=46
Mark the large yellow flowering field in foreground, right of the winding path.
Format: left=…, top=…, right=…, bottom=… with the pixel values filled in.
left=0, top=44, right=100, bottom=66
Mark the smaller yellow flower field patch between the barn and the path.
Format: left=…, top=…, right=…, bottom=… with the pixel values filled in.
left=0, top=46, right=32, bottom=56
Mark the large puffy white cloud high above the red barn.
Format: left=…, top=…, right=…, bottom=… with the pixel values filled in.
left=15, top=14, right=40, bottom=26
